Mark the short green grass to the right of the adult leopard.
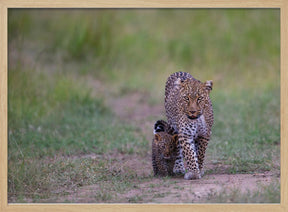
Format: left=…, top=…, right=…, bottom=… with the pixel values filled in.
left=208, top=86, right=280, bottom=173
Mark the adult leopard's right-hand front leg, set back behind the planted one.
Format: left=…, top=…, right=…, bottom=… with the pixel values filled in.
left=195, top=136, right=209, bottom=177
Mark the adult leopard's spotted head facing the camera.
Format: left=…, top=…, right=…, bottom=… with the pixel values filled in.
left=175, top=78, right=213, bottom=119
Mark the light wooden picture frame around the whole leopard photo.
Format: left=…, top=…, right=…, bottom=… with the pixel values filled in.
left=0, top=0, right=288, bottom=212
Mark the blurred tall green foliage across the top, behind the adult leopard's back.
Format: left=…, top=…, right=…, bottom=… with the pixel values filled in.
left=9, top=9, right=280, bottom=91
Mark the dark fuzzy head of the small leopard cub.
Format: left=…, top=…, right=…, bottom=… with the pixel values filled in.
left=154, top=132, right=178, bottom=160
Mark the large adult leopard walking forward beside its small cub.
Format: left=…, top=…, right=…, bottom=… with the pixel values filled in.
left=165, top=71, right=214, bottom=180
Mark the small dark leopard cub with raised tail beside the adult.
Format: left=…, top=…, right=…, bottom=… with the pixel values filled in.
left=152, top=120, right=178, bottom=176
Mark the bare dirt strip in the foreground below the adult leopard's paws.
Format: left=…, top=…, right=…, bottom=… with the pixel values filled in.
left=120, top=168, right=274, bottom=203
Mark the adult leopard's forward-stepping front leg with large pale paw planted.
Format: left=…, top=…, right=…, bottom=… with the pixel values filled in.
left=178, top=132, right=201, bottom=180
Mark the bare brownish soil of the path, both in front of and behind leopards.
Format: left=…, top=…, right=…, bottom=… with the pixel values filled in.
left=50, top=93, right=280, bottom=203
